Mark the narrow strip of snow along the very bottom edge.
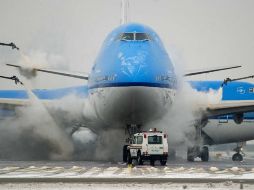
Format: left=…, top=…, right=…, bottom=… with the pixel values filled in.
left=0, top=181, right=254, bottom=190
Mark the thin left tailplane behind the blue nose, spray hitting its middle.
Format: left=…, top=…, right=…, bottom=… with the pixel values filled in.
left=6, top=64, right=88, bottom=80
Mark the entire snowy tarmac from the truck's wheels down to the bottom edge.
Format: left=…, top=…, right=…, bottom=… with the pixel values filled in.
left=0, top=159, right=254, bottom=190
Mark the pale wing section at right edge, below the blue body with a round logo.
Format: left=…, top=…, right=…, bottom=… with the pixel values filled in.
left=205, top=100, right=254, bottom=117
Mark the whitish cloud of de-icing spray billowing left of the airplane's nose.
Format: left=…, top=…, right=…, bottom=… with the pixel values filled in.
left=0, top=52, right=125, bottom=160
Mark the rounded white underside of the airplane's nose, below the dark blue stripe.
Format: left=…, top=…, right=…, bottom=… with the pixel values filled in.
left=90, top=87, right=175, bottom=127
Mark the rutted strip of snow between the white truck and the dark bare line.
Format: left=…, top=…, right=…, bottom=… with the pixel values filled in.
left=0, top=164, right=254, bottom=181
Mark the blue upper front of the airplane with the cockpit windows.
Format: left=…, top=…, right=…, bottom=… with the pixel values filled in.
left=88, top=24, right=176, bottom=89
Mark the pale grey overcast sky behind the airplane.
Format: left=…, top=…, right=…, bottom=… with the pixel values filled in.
left=0, top=0, right=254, bottom=88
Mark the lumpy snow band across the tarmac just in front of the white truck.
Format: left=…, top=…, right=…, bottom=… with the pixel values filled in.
left=0, top=164, right=254, bottom=183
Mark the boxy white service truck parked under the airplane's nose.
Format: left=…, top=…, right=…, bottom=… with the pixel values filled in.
left=126, top=129, right=168, bottom=166
